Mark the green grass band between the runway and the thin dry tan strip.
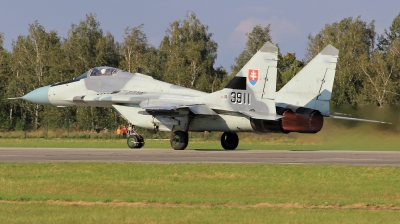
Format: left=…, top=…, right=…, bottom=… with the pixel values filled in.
left=0, top=163, right=400, bottom=206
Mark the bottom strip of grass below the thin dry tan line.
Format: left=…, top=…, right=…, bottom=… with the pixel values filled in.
left=0, top=203, right=400, bottom=223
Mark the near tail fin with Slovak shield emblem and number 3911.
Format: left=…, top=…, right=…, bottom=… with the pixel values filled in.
left=204, top=42, right=278, bottom=120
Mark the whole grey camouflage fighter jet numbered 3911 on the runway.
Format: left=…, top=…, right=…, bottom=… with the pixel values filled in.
left=22, top=42, right=388, bottom=150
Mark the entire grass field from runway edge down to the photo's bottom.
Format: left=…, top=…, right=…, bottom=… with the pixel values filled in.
left=0, top=163, right=400, bottom=223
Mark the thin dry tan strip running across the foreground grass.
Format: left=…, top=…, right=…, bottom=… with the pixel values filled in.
left=0, top=200, right=400, bottom=210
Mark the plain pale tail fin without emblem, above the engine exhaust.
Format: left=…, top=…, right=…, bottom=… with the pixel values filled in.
left=276, top=45, right=339, bottom=116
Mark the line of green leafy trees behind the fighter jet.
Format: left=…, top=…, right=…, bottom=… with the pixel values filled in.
left=0, top=12, right=400, bottom=129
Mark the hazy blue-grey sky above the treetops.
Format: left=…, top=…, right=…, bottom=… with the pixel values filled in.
left=0, top=0, right=400, bottom=71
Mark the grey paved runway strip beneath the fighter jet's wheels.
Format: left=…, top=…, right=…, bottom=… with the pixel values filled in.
left=0, top=148, right=400, bottom=166
